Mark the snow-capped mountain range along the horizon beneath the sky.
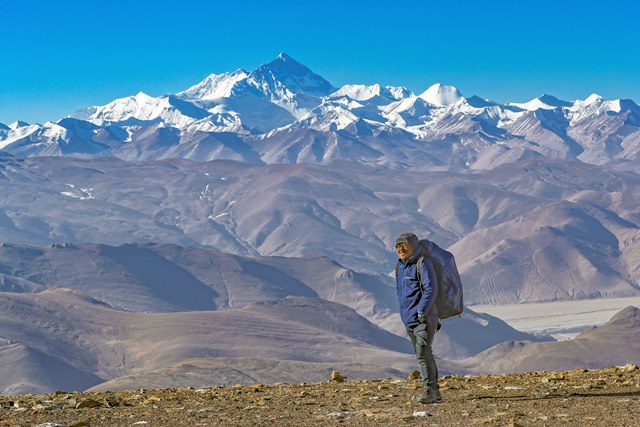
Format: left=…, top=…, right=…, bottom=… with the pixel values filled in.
left=0, top=53, right=640, bottom=169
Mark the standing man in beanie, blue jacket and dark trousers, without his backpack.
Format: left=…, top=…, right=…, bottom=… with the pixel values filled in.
left=396, top=233, right=442, bottom=403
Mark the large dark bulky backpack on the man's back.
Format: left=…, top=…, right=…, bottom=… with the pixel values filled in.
left=417, top=239, right=464, bottom=319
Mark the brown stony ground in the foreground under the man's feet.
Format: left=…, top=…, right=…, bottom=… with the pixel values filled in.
left=0, top=365, right=640, bottom=427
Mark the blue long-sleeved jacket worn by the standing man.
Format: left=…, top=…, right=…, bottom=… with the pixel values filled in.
left=396, top=247, right=438, bottom=328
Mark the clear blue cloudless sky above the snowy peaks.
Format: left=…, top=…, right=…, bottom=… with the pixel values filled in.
left=0, top=0, right=640, bottom=124
